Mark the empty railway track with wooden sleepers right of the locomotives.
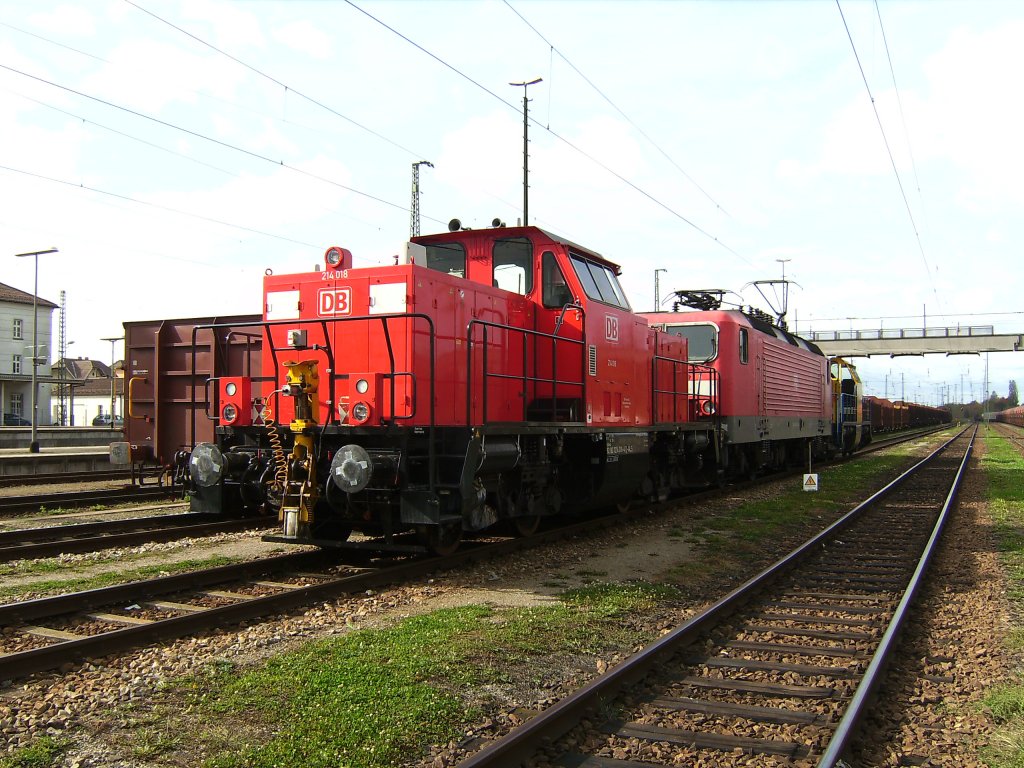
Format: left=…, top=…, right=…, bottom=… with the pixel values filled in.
left=461, top=428, right=977, bottom=768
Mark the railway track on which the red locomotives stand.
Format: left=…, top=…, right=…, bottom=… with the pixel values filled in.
left=0, top=428, right=954, bottom=681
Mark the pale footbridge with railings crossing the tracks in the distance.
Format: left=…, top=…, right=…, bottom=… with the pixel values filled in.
left=804, top=326, right=1024, bottom=357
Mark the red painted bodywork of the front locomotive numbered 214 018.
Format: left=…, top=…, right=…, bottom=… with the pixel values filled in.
left=261, top=227, right=693, bottom=434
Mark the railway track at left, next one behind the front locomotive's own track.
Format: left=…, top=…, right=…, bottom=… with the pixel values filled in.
left=0, top=513, right=278, bottom=562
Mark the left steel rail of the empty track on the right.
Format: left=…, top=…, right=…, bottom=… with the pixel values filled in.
left=459, top=427, right=967, bottom=768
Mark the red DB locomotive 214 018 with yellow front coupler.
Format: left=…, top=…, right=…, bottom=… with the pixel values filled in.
left=182, top=221, right=720, bottom=552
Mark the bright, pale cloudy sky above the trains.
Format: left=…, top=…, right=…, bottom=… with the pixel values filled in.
left=0, top=0, right=1024, bottom=403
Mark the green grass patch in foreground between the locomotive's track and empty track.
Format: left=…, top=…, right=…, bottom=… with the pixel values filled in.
left=134, top=583, right=678, bottom=768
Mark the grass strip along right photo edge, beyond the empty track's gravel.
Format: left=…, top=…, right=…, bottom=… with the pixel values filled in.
left=981, top=426, right=1024, bottom=768
